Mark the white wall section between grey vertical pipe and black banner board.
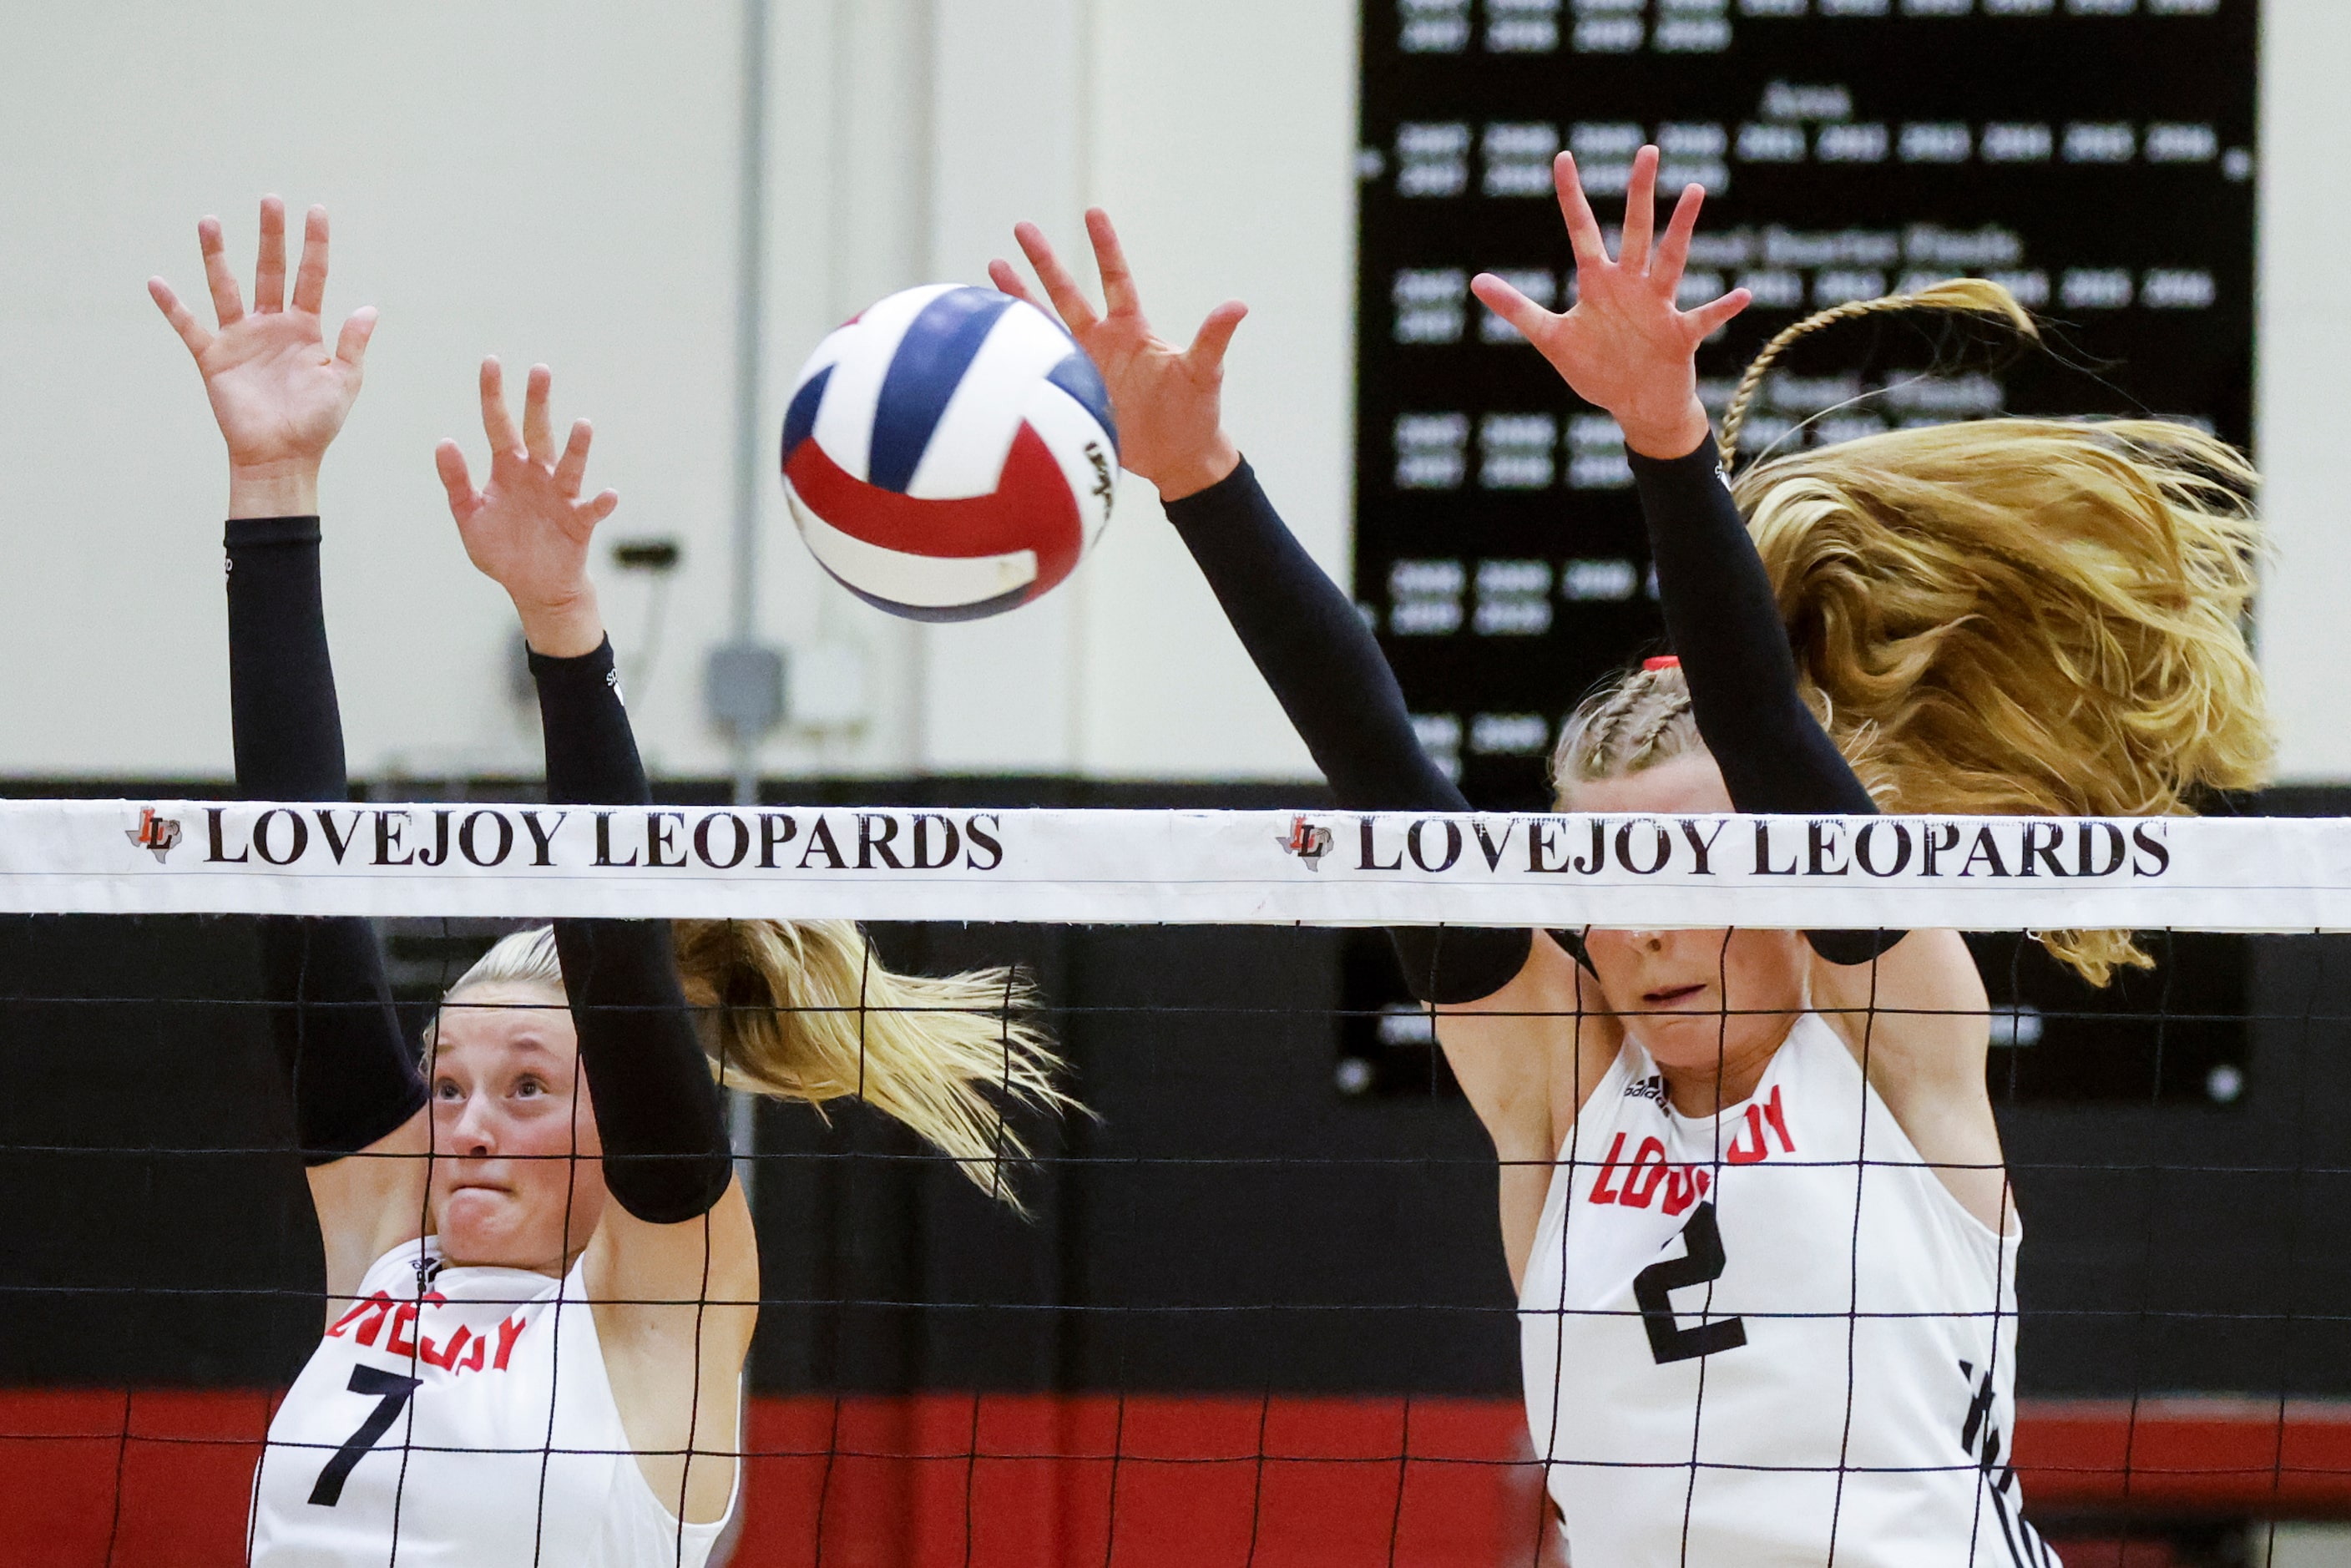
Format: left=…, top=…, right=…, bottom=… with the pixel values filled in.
left=761, top=0, right=1357, bottom=778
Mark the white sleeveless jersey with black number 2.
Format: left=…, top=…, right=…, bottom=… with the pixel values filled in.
left=1519, top=1014, right=2057, bottom=1568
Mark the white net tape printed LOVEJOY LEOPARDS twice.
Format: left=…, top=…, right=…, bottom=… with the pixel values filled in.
left=13, top=799, right=2351, bottom=931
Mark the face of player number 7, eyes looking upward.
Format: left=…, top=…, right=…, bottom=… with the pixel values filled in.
left=432, top=985, right=604, bottom=1274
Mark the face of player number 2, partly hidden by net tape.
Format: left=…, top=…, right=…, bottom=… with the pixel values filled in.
left=1564, top=752, right=1810, bottom=1115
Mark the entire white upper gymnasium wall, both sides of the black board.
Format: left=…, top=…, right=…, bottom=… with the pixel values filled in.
left=0, top=0, right=2351, bottom=781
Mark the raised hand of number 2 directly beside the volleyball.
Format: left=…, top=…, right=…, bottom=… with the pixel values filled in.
left=988, top=207, right=1248, bottom=501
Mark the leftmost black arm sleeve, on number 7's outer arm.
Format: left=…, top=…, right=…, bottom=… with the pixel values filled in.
left=228, top=517, right=426, bottom=1166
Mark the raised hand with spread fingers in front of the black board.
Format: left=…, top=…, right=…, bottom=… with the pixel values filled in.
left=1469, top=148, right=1752, bottom=458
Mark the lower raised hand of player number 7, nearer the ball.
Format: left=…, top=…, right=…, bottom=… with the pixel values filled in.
left=432, top=360, right=620, bottom=658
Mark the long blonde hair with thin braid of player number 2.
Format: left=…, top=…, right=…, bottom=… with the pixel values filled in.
left=1554, top=280, right=2271, bottom=985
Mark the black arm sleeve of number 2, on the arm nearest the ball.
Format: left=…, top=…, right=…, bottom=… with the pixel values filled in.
left=1166, top=461, right=1533, bottom=1004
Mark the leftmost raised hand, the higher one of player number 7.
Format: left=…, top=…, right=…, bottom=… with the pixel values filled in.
left=148, top=195, right=377, bottom=517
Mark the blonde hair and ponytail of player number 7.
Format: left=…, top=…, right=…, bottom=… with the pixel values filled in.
left=426, top=919, right=1081, bottom=1213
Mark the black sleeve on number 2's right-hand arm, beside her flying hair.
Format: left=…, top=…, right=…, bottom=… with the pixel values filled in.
left=1629, top=435, right=1902, bottom=964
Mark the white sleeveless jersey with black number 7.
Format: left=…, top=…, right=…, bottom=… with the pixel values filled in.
left=251, top=1237, right=741, bottom=1568
